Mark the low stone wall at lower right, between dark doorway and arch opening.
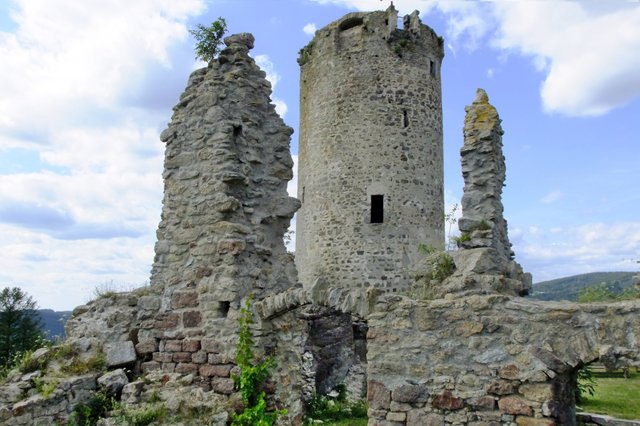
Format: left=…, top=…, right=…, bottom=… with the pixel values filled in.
left=367, top=294, right=640, bottom=426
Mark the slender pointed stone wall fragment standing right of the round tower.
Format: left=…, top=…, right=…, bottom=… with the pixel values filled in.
left=448, top=89, right=531, bottom=295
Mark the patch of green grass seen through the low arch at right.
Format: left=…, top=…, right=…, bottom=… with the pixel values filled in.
left=579, top=368, right=640, bottom=420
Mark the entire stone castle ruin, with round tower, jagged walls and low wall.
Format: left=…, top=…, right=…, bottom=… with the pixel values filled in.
left=0, top=8, right=640, bottom=426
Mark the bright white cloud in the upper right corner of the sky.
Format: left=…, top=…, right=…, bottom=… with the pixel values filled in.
left=494, top=2, right=640, bottom=115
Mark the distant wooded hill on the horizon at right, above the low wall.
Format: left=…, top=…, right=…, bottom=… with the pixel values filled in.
left=530, top=272, right=638, bottom=301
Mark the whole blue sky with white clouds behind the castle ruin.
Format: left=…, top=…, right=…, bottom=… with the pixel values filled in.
left=0, top=0, right=640, bottom=309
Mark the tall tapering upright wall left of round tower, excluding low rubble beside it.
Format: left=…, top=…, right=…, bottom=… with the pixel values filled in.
left=137, top=30, right=299, bottom=393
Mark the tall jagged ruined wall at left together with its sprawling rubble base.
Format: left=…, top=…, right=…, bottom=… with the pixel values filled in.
left=0, top=33, right=307, bottom=424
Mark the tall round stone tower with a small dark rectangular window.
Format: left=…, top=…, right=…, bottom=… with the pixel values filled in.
left=296, top=6, right=444, bottom=291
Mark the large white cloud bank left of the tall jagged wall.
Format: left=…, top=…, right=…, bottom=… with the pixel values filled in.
left=0, top=0, right=203, bottom=309
